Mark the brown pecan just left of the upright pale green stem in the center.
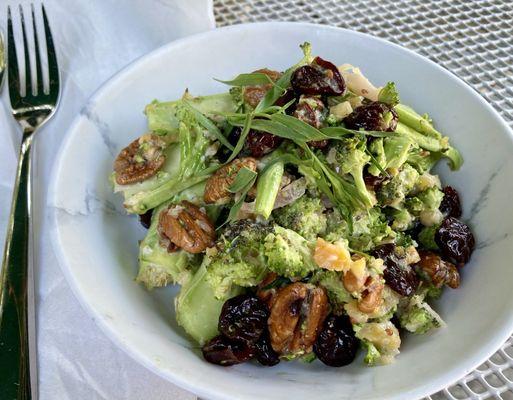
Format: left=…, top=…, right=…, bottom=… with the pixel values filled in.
left=203, top=157, right=257, bottom=204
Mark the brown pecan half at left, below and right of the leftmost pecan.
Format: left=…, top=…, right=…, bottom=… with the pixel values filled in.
left=158, top=201, right=215, bottom=253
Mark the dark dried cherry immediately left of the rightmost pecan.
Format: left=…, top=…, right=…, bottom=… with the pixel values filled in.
left=372, top=243, right=419, bottom=296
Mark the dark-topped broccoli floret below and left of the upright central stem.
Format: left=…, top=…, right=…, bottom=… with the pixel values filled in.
left=205, top=220, right=269, bottom=299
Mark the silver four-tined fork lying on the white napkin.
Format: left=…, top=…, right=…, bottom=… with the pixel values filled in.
left=0, top=5, right=60, bottom=400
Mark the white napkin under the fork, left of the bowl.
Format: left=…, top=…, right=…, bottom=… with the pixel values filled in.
left=0, top=0, right=215, bottom=400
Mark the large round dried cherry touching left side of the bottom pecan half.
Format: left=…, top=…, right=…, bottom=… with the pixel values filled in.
left=219, top=294, right=269, bottom=343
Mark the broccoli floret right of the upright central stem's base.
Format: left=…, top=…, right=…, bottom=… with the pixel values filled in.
left=272, top=196, right=326, bottom=240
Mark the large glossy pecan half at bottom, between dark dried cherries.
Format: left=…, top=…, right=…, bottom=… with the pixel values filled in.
left=268, top=282, right=328, bottom=354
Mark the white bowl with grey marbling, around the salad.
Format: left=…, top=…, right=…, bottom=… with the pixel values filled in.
left=49, top=23, right=513, bottom=400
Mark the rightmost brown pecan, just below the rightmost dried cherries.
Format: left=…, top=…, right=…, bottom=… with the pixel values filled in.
left=416, top=250, right=460, bottom=289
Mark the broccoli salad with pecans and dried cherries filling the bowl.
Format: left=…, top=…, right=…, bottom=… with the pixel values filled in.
left=111, top=43, right=475, bottom=367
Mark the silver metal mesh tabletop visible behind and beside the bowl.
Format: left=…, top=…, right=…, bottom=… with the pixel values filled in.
left=214, top=0, right=513, bottom=400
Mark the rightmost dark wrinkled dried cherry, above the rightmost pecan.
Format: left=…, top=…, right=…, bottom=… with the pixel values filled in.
left=435, top=217, right=475, bottom=267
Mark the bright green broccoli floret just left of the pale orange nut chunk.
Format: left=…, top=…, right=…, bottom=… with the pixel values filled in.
left=264, top=225, right=317, bottom=279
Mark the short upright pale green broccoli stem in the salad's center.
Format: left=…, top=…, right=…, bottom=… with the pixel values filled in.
left=255, top=161, right=284, bottom=219
